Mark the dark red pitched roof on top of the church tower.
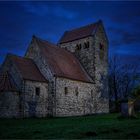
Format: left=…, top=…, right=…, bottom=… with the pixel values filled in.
left=59, top=20, right=101, bottom=44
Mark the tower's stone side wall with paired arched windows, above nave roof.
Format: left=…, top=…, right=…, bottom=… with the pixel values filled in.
left=59, top=36, right=95, bottom=81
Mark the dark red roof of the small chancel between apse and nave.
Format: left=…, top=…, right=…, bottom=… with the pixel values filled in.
left=10, top=55, right=47, bottom=82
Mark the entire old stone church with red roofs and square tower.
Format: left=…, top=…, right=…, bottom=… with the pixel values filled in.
left=0, top=21, right=109, bottom=118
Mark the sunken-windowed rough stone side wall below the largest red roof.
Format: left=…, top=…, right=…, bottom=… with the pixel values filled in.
left=55, top=78, right=97, bottom=116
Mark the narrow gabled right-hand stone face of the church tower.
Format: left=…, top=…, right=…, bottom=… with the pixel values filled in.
left=95, top=24, right=109, bottom=113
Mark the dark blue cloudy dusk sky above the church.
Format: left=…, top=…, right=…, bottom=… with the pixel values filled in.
left=0, top=1, right=140, bottom=63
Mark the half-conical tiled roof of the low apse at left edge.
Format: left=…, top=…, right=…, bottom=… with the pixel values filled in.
left=0, top=72, right=18, bottom=91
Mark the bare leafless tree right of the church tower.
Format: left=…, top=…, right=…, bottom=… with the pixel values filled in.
left=109, top=56, right=137, bottom=111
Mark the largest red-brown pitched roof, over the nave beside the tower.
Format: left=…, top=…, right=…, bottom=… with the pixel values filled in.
left=36, top=38, right=92, bottom=82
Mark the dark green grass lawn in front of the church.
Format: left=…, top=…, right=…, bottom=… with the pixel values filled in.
left=0, top=114, right=140, bottom=139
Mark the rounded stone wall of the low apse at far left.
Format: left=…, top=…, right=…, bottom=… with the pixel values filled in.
left=0, top=91, right=20, bottom=118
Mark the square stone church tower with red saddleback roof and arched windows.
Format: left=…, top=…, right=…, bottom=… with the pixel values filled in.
left=58, top=20, right=108, bottom=98
